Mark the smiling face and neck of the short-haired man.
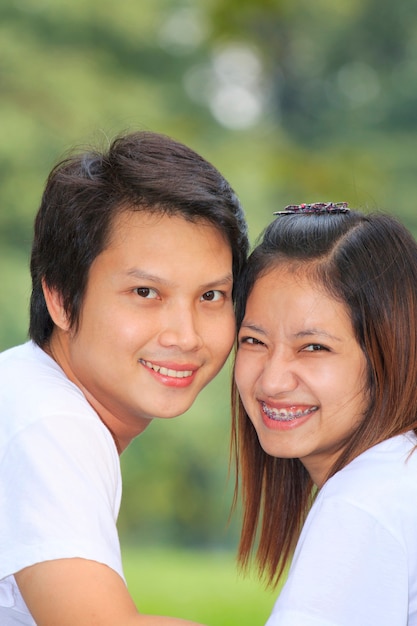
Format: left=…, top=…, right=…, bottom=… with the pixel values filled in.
left=50, top=211, right=235, bottom=449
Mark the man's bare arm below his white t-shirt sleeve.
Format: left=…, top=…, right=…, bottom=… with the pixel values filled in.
left=15, top=558, right=202, bottom=626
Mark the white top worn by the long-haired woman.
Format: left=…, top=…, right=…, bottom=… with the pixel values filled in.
left=267, top=433, right=417, bottom=626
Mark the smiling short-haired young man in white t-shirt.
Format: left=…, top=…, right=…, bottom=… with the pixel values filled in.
left=0, top=133, right=248, bottom=626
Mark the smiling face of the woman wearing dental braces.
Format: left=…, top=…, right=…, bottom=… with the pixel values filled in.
left=235, top=266, right=367, bottom=487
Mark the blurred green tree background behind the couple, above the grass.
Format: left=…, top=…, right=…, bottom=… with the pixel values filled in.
left=0, top=0, right=417, bottom=626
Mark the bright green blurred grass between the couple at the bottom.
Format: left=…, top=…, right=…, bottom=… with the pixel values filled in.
left=122, top=545, right=278, bottom=626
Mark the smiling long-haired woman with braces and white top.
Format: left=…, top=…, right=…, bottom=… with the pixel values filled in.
left=233, top=203, right=417, bottom=626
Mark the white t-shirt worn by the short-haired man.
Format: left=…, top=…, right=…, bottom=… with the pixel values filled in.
left=0, top=342, right=123, bottom=626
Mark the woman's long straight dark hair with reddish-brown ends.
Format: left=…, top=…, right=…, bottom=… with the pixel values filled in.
left=232, top=211, right=417, bottom=585
